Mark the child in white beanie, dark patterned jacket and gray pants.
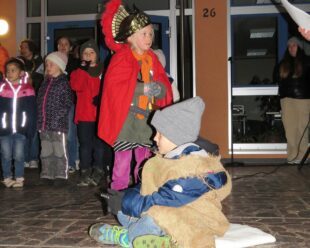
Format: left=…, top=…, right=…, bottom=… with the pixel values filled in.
left=37, top=52, right=72, bottom=185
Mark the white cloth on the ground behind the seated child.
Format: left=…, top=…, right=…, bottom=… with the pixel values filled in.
left=215, top=224, right=276, bottom=248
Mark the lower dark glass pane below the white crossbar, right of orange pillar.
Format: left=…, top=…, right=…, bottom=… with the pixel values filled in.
left=232, top=95, right=286, bottom=143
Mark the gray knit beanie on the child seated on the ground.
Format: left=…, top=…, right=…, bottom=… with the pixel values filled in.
left=151, top=96, right=205, bottom=146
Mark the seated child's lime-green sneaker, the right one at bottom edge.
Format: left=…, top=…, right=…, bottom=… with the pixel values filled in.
left=133, top=234, right=177, bottom=248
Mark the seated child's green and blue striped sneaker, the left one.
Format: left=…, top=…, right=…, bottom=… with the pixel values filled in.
left=89, top=223, right=129, bottom=248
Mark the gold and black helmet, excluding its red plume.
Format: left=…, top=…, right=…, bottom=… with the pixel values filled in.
left=112, top=5, right=151, bottom=42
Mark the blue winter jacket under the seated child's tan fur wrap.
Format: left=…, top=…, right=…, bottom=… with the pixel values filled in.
left=122, top=145, right=227, bottom=217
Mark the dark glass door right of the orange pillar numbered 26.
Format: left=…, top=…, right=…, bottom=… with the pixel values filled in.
left=231, top=15, right=285, bottom=148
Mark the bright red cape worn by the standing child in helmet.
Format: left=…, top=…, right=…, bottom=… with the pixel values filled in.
left=98, top=45, right=172, bottom=146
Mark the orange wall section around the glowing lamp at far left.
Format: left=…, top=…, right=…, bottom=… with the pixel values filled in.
left=0, top=0, right=17, bottom=56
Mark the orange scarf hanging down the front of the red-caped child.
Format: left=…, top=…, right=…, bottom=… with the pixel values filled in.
left=132, top=51, right=153, bottom=119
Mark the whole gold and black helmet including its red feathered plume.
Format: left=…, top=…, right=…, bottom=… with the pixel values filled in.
left=101, top=0, right=151, bottom=51
